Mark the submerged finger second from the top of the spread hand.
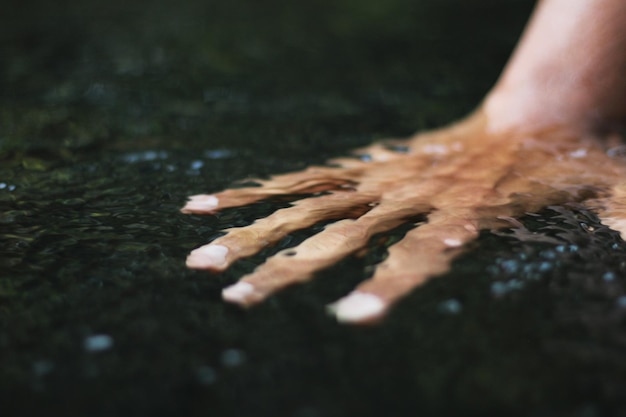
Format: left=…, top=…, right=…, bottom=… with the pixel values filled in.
left=187, top=192, right=376, bottom=271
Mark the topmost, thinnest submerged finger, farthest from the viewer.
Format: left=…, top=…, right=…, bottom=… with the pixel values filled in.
left=181, top=167, right=359, bottom=214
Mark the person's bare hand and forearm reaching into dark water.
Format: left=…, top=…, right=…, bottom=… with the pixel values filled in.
left=182, top=0, right=626, bottom=323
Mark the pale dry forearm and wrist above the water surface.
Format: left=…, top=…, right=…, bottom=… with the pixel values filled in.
left=485, top=0, right=626, bottom=130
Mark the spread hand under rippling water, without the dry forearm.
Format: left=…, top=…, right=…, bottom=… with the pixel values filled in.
left=182, top=112, right=626, bottom=323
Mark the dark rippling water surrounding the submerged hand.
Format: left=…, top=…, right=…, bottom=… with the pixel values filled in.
left=0, top=0, right=626, bottom=417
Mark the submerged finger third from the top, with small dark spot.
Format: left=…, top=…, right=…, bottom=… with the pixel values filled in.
left=217, top=205, right=423, bottom=306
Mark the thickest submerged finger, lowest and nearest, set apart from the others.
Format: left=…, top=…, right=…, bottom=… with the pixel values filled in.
left=329, top=212, right=478, bottom=323
